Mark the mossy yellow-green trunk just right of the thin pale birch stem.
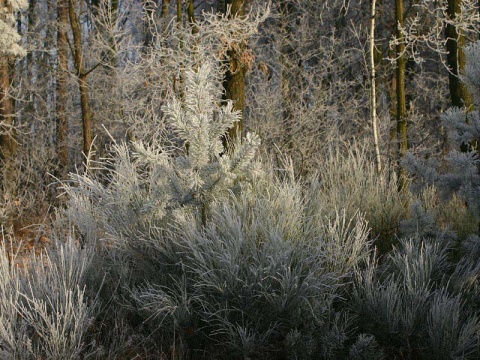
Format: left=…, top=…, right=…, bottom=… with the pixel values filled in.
left=395, top=0, right=408, bottom=189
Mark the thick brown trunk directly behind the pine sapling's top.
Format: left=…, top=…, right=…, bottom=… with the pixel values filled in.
left=223, top=0, right=246, bottom=142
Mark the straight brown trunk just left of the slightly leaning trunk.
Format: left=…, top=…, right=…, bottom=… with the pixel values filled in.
left=57, top=0, right=69, bottom=179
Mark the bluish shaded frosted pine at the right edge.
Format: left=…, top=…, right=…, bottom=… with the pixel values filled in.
left=404, top=42, right=480, bottom=240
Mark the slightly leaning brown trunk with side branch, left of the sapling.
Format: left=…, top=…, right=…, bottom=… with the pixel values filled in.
left=68, top=0, right=93, bottom=157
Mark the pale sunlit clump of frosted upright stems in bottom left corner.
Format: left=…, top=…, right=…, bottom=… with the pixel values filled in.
left=18, top=240, right=95, bottom=359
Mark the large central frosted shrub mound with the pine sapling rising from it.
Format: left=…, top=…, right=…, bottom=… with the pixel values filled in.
left=65, top=65, right=375, bottom=359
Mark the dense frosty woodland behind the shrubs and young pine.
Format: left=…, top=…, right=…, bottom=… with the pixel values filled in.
left=0, top=0, right=479, bottom=227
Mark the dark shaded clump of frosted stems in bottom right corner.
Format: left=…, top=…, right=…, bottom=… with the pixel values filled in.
left=352, top=238, right=480, bottom=360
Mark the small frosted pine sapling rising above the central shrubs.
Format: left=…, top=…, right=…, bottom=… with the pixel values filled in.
left=164, top=63, right=260, bottom=225
